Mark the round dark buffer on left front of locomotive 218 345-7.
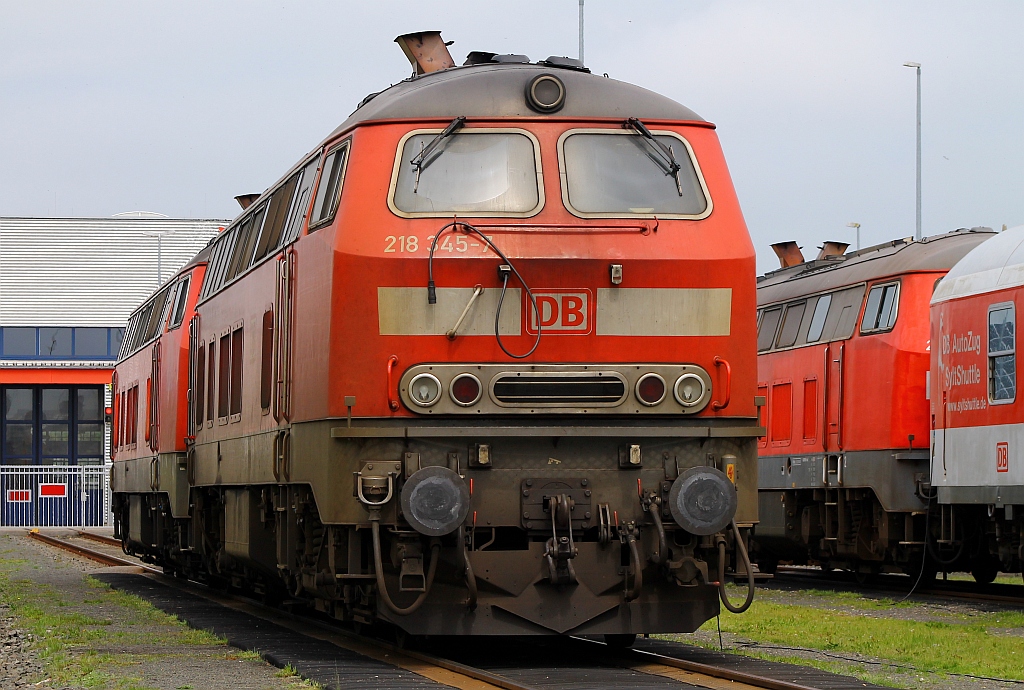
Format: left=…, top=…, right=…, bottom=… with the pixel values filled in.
left=401, top=467, right=469, bottom=536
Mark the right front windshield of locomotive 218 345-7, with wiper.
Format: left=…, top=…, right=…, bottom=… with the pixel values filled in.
left=561, top=130, right=708, bottom=217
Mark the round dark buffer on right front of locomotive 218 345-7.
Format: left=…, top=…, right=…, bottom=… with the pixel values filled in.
left=669, top=467, right=737, bottom=536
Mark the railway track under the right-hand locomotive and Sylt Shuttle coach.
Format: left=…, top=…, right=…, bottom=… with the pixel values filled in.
left=763, top=565, right=1024, bottom=606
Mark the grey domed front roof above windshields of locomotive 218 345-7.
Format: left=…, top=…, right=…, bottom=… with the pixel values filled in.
left=331, top=62, right=705, bottom=137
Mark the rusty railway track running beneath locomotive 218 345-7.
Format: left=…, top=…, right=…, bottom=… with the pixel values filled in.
left=29, top=531, right=864, bottom=690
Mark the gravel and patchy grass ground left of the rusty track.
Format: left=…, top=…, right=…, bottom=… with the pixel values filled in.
left=0, top=530, right=308, bottom=690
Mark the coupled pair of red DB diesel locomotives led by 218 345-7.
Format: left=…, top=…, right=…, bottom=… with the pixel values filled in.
left=112, top=33, right=762, bottom=642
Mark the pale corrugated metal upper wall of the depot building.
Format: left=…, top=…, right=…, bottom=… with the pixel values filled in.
left=0, top=217, right=230, bottom=327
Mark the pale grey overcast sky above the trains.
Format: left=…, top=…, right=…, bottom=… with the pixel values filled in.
left=0, top=0, right=1024, bottom=271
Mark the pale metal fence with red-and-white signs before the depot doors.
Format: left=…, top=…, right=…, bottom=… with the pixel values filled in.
left=0, top=465, right=112, bottom=527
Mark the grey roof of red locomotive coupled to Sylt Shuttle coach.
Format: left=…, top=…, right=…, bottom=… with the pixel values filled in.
left=758, top=227, right=995, bottom=305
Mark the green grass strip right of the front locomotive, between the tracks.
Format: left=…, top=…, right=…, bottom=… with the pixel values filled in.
left=675, top=588, right=1024, bottom=684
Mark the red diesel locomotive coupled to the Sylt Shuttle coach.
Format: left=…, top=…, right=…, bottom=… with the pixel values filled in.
left=756, top=228, right=993, bottom=575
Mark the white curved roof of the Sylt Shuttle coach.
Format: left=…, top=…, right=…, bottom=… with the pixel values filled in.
left=932, top=225, right=1024, bottom=304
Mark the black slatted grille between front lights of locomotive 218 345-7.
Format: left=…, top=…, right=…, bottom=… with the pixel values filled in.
left=492, top=372, right=628, bottom=407
